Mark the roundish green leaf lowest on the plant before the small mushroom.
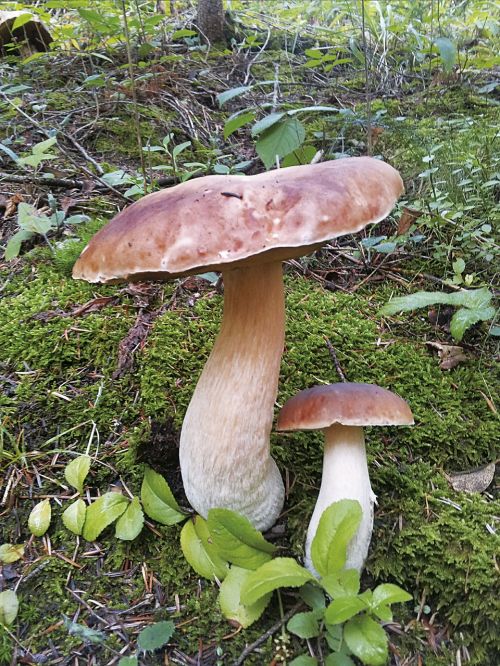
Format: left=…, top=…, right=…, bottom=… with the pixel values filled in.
left=344, top=615, right=388, bottom=666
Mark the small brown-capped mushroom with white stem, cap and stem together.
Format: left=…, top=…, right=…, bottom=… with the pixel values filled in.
left=277, top=382, right=414, bottom=573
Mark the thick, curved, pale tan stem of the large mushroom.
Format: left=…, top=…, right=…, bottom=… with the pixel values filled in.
left=179, top=262, right=285, bottom=530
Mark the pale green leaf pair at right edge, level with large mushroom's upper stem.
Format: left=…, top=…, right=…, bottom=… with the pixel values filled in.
left=379, top=287, right=496, bottom=341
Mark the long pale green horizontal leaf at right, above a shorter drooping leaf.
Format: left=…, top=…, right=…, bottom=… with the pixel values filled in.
left=379, top=287, right=492, bottom=315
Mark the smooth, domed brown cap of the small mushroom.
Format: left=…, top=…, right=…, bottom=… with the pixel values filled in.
left=277, top=382, right=414, bottom=430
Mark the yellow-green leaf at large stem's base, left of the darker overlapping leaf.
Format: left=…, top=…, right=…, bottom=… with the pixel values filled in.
left=181, top=516, right=229, bottom=580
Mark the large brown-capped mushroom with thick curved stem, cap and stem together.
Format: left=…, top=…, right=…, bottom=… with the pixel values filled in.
left=73, top=157, right=403, bottom=530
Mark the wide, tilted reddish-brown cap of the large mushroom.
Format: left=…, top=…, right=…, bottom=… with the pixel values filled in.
left=73, top=157, right=403, bottom=282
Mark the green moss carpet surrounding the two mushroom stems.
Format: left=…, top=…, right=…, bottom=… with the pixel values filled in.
left=0, top=222, right=500, bottom=664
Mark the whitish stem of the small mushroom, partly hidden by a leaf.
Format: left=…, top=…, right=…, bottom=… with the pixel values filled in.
left=305, top=423, right=376, bottom=575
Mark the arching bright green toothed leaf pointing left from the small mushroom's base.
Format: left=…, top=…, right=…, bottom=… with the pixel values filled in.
left=241, top=557, right=316, bottom=604
